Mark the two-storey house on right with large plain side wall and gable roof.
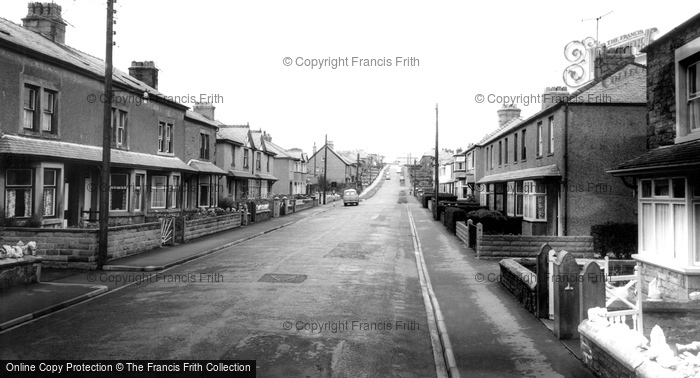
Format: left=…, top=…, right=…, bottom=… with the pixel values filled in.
left=474, top=60, right=646, bottom=236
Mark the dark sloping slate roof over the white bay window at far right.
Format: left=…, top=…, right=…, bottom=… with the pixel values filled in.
left=607, top=139, right=700, bottom=176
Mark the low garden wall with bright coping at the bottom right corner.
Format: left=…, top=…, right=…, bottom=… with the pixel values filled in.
left=578, top=320, right=669, bottom=378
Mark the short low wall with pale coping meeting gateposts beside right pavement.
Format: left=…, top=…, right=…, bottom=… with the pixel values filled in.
left=499, top=259, right=537, bottom=314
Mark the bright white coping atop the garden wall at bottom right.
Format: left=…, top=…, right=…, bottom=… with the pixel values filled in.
left=578, top=319, right=669, bottom=378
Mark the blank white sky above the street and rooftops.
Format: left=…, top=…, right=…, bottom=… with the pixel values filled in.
left=0, top=0, right=700, bottom=161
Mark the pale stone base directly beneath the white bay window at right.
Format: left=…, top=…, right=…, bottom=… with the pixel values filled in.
left=639, top=261, right=700, bottom=301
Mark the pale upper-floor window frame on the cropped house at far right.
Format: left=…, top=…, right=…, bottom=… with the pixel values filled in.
left=674, top=37, right=700, bottom=143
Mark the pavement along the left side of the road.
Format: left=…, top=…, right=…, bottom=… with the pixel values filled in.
left=0, top=203, right=333, bottom=332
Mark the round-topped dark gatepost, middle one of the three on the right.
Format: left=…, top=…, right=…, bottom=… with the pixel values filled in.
left=552, top=251, right=581, bottom=340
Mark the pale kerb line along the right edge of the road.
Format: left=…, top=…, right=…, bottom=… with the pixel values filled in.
left=406, top=205, right=459, bottom=378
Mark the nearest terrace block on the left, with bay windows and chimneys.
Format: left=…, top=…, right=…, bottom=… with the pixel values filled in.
left=0, top=3, right=202, bottom=227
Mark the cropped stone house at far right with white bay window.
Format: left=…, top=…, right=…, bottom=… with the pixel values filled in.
left=608, top=14, right=700, bottom=300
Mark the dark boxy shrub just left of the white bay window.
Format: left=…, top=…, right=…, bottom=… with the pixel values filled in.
left=591, top=222, right=638, bottom=260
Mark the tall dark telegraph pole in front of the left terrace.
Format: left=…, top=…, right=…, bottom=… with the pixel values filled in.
left=97, top=0, right=114, bottom=269
